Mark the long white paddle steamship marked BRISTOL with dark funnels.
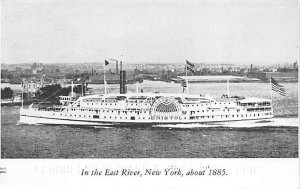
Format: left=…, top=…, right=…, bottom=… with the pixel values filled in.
left=20, top=65, right=273, bottom=126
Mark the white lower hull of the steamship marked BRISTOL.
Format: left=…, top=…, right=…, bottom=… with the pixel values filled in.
left=20, top=106, right=273, bottom=125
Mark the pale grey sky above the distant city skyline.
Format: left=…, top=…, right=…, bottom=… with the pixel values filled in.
left=1, top=0, right=299, bottom=64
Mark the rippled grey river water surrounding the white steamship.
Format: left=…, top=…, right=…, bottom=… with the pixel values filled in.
left=1, top=81, right=299, bottom=158
